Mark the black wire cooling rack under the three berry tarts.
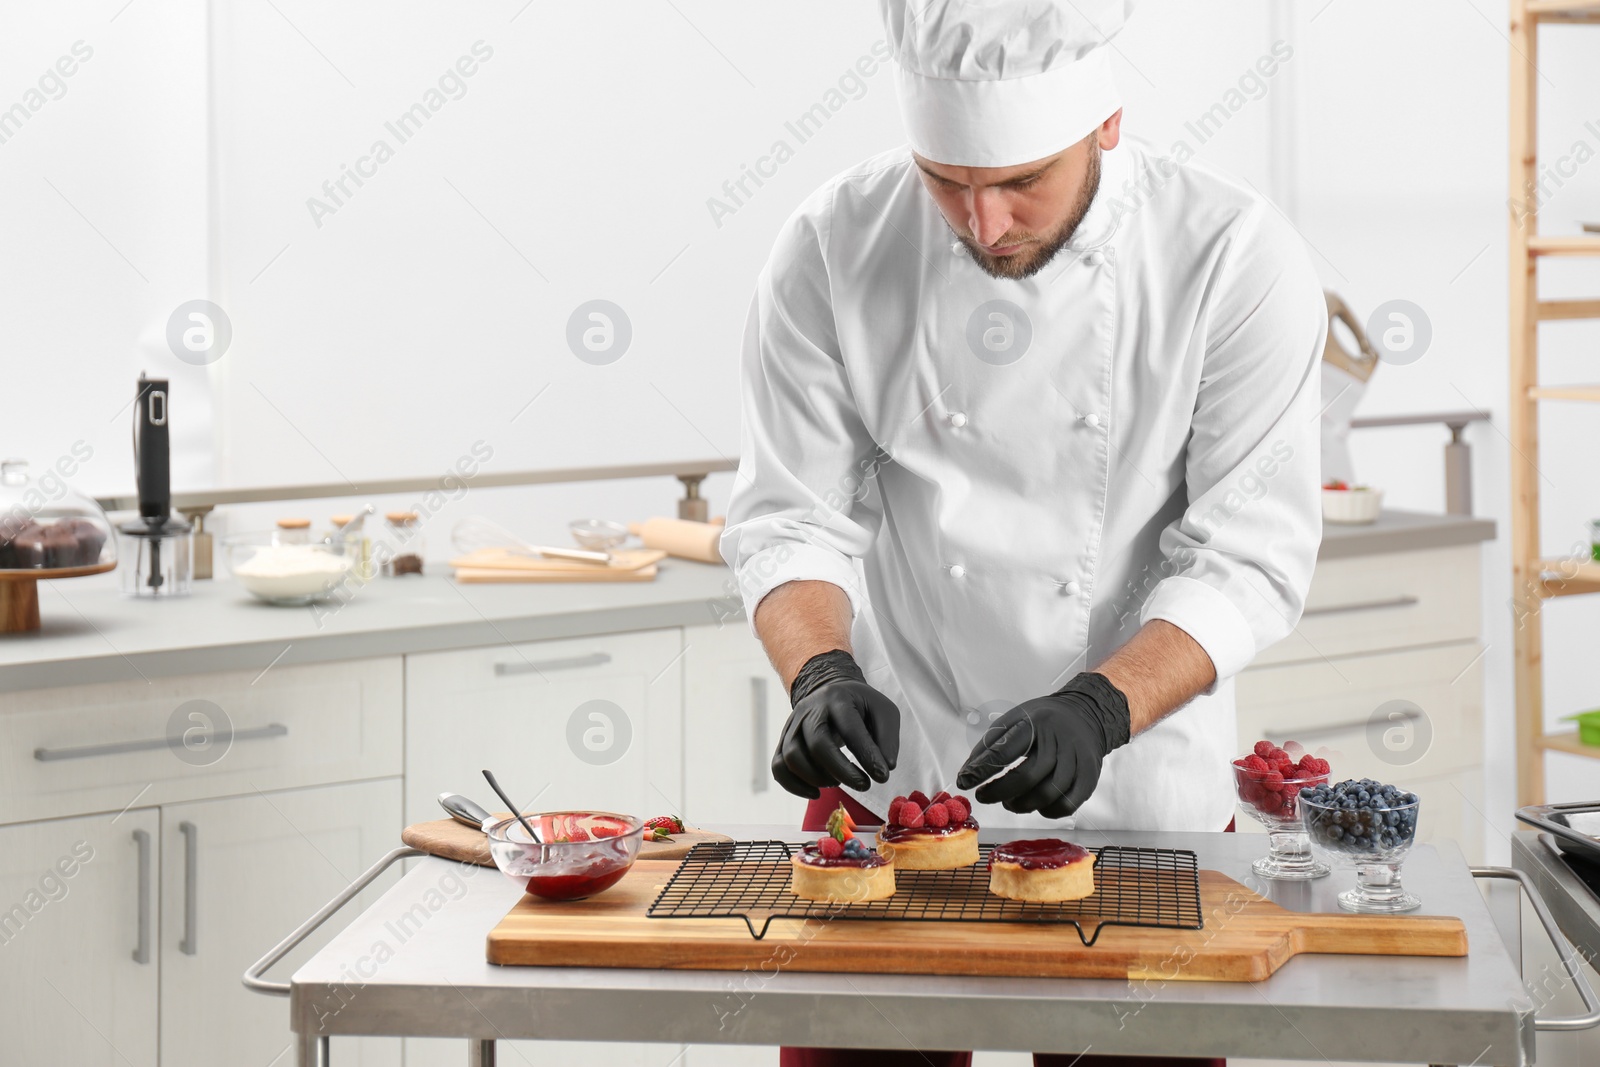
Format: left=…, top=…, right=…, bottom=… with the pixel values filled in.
left=648, top=841, right=1205, bottom=945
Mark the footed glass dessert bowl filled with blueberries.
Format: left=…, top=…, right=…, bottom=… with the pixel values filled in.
left=1299, top=777, right=1422, bottom=913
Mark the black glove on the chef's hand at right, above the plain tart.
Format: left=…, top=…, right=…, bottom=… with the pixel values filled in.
left=955, top=672, right=1131, bottom=819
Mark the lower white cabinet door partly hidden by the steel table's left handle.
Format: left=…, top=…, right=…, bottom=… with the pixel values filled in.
left=158, top=779, right=402, bottom=1067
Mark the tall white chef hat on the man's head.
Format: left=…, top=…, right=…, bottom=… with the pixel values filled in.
left=878, top=0, right=1134, bottom=166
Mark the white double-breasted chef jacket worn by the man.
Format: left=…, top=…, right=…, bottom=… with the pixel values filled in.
left=722, top=136, right=1328, bottom=830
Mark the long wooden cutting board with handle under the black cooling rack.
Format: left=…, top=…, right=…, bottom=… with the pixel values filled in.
left=488, top=861, right=1467, bottom=982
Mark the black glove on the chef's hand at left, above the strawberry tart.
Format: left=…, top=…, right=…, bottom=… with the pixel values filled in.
left=773, top=648, right=899, bottom=800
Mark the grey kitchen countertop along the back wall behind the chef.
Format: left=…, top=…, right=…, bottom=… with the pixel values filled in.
left=0, top=510, right=1494, bottom=691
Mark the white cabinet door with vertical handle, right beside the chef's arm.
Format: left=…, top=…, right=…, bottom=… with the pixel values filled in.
left=683, top=619, right=805, bottom=827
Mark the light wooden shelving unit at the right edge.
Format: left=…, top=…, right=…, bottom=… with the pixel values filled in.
left=1509, top=0, right=1600, bottom=805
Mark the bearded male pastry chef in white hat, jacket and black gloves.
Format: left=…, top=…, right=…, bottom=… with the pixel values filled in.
left=722, top=0, right=1326, bottom=1064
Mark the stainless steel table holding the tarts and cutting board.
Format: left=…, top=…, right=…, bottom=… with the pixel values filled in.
left=246, top=827, right=1600, bottom=1067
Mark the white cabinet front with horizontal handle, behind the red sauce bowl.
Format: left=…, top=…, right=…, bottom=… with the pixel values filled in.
left=405, top=629, right=683, bottom=822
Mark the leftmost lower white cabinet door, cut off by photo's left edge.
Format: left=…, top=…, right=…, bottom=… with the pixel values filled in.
left=0, top=808, right=162, bottom=1067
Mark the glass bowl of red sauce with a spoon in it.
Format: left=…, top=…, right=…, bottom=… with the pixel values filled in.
left=483, top=811, right=645, bottom=901
